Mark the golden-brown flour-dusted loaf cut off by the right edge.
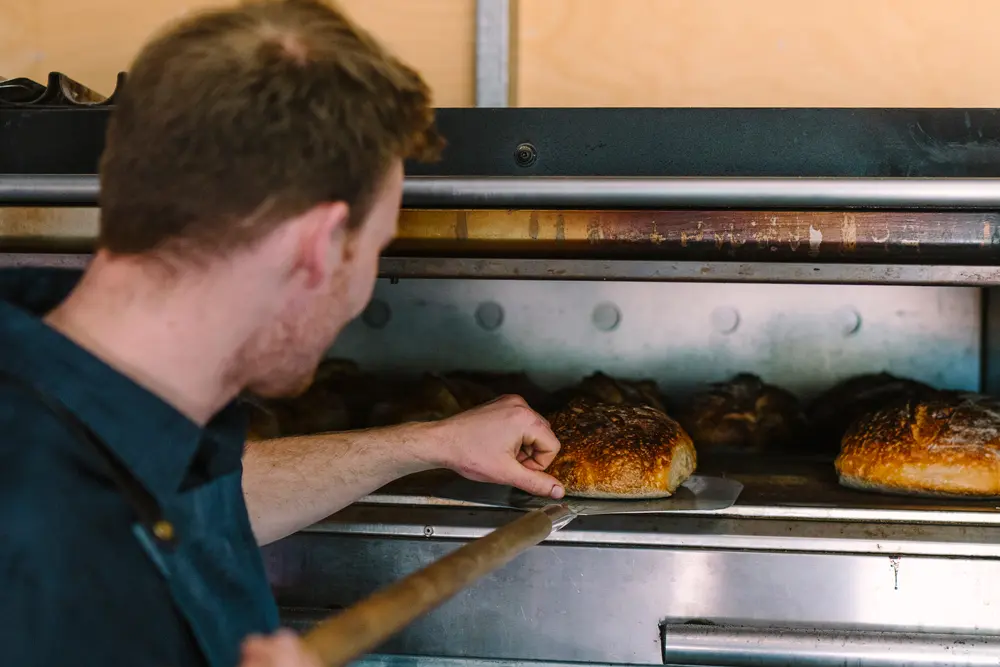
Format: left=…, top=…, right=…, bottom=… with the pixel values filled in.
left=835, top=394, right=1000, bottom=498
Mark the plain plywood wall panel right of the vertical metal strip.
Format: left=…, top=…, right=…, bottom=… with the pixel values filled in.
left=514, top=0, right=1000, bottom=107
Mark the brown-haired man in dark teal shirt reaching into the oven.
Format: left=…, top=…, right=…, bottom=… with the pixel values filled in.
left=0, top=0, right=563, bottom=667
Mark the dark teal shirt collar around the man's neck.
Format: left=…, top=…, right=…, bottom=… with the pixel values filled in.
left=0, top=269, right=243, bottom=496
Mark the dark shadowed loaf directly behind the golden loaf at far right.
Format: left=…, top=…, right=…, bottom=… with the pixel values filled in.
left=806, top=373, right=937, bottom=450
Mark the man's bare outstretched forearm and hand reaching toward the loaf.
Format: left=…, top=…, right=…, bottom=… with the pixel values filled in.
left=243, top=396, right=563, bottom=544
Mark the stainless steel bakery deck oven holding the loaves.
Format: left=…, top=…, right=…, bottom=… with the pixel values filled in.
left=0, top=75, right=1000, bottom=667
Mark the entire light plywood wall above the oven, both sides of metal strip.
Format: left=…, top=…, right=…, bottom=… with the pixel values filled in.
left=0, top=0, right=1000, bottom=107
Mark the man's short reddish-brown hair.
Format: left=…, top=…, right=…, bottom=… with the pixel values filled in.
left=99, top=0, right=442, bottom=255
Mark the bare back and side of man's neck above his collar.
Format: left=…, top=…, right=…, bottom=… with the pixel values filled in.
left=46, top=255, right=272, bottom=425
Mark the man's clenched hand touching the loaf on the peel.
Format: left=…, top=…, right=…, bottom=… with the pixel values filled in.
left=425, top=396, right=565, bottom=499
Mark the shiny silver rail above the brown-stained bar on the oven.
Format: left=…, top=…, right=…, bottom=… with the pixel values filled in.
left=11, top=174, right=1000, bottom=210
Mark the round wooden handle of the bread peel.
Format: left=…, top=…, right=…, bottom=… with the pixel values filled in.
left=303, top=505, right=571, bottom=667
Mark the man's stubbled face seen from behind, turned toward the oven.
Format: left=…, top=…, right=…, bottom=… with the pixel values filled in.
left=242, top=161, right=403, bottom=397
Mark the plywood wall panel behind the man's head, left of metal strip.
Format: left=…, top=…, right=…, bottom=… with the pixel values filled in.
left=0, top=0, right=475, bottom=106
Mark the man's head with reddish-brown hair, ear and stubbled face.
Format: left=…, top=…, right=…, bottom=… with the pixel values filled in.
left=99, top=0, right=441, bottom=395
